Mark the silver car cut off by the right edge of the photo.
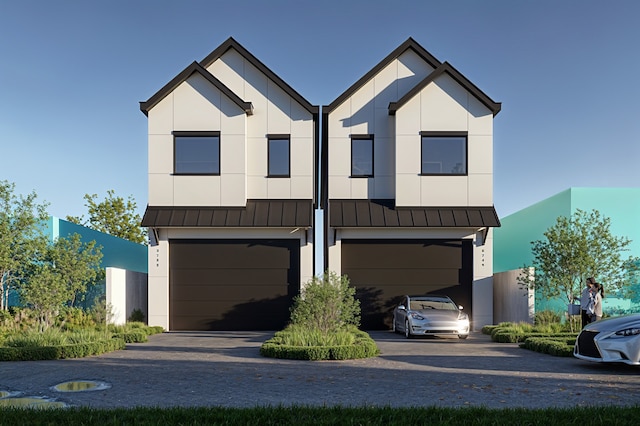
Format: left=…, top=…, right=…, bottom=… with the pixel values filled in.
left=573, top=314, right=640, bottom=365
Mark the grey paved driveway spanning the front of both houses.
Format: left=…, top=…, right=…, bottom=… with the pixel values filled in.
left=0, top=331, right=640, bottom=408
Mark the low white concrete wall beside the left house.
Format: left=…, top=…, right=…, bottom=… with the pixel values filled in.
left=106, top=268, right=149, bottom=325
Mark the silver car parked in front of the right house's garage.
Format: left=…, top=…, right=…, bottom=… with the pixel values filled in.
left=391, top=295, right=469, bottom=339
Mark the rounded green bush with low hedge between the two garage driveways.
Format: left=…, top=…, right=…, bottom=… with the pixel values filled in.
left=260, top=272, right=380, bottom=361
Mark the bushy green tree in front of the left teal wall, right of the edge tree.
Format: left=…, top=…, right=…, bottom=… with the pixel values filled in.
left=20, top=234, right=102, bottom=330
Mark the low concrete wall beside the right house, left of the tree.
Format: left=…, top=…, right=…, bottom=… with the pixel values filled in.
left=493, top=269, right=535, bottom=324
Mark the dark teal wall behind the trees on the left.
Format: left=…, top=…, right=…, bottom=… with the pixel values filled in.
left=46, top=216, right=148, bottom=273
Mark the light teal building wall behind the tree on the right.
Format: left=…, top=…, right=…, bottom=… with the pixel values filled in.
left=493, top=188, right=640, bottom=310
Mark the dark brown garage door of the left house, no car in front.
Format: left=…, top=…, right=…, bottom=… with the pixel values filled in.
left=169, top=240, right=300, bottom=330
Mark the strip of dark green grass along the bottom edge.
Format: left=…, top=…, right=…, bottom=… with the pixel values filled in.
left=0, top=406, right=640, bottom=426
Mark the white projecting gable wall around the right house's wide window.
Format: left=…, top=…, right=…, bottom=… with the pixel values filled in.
left=396, top=74, right=493, bottom=206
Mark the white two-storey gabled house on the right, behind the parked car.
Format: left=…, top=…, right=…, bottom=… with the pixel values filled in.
left=321, top=38, right=501, bottom=329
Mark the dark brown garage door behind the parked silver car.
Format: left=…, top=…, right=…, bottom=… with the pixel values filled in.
left=342, top=240, right=473, bottom=330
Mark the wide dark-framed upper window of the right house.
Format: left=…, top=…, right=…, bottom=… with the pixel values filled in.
left=420, top=132, right=467, bottom=175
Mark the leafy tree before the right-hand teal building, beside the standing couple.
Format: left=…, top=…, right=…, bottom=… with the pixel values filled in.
left=520, top=209, right=634, bottom=310
